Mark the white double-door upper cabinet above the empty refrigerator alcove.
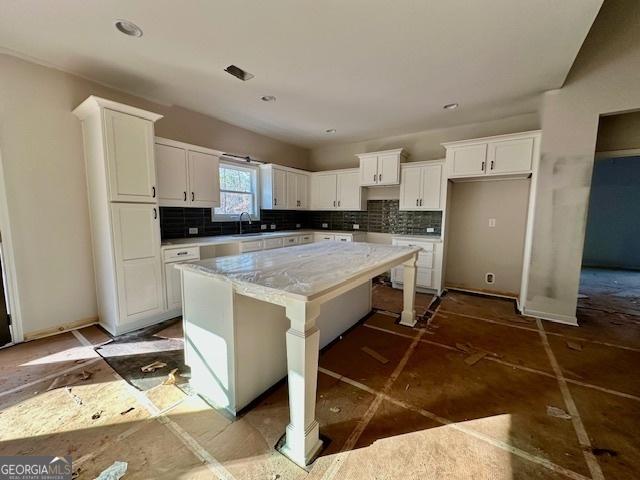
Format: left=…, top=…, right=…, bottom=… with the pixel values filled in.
left=442, top=131, right=540, bottom=179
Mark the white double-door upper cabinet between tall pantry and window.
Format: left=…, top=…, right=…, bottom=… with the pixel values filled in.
left=155, top=137, right=220, bottom=208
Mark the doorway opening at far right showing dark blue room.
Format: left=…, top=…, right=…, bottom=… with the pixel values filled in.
left=578, top=112, right=640, bottom=322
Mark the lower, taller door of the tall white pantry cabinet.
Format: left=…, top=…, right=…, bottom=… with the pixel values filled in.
left=111, top=203, right=164, bottom=323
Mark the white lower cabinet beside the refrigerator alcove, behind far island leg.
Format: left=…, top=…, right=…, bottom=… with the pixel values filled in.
left=391, top=238, right=442, bottom=293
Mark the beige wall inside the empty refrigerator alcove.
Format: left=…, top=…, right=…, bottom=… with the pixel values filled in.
left=445, top=179, right=530, bottom=296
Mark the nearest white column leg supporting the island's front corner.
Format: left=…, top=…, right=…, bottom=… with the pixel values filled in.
left=280, top=301, right=322, bottom=467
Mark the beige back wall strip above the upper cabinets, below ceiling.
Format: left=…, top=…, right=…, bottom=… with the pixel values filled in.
left=310, top=113, right=540, bottom=171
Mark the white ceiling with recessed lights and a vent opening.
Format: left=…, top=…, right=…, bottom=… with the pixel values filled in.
left=0, top=0, right=602, bottom=147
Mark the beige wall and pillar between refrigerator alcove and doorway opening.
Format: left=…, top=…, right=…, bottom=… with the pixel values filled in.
left=526, top=0, right=640, bottom=321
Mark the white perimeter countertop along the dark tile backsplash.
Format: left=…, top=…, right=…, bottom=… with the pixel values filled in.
left=161, top=229, right=442, bottom=249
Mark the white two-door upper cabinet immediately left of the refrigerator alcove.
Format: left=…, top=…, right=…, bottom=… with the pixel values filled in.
left=400, top=162, right=444, bottom=210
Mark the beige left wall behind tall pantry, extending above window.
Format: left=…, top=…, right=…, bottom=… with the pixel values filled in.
left=0, top=55, right=308, bottom=334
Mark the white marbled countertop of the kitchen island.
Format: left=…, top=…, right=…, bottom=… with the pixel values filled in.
left=176, top=242, right=420, bottom=305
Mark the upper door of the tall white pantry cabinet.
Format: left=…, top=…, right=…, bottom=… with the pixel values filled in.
left=104, top=109, right=156, bottom=203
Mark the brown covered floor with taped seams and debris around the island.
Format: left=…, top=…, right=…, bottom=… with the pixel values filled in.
left=0, top=287, right=640, bottom=480
